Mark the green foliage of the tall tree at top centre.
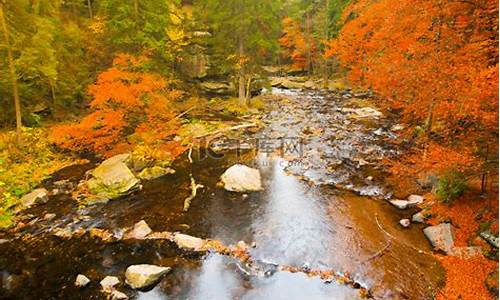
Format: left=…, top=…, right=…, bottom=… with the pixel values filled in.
left=196, top=0, right=282, bottom=74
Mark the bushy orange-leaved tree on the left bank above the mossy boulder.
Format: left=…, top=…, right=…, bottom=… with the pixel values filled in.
left=51, top=54, right=184, bottom=158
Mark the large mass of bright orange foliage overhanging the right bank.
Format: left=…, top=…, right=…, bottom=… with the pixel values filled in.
left=326, top=0, right=498, bottom=189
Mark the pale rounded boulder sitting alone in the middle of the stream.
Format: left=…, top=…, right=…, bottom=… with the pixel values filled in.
left=221, top=164, right=262, bottom=193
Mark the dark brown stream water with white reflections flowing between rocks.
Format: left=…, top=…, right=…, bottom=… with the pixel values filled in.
left=0, top=90, right=442, bottom=299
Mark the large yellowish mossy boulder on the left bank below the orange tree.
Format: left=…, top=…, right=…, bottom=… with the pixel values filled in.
left=87, top=154, right=140, bottom=199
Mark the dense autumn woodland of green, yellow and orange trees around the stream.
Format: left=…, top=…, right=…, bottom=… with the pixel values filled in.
left=0, top=0, right=499, bottom=299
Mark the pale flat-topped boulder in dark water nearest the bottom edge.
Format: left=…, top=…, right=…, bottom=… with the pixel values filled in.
left=125, top=264, right=171, bottom=290
